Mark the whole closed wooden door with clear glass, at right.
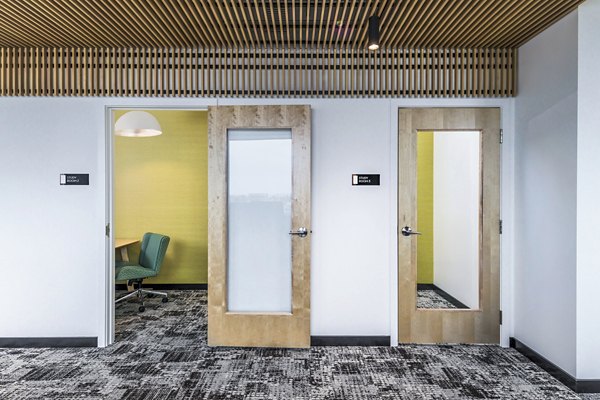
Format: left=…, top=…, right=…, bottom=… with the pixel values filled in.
left=398, top=108, right=500, bottom=343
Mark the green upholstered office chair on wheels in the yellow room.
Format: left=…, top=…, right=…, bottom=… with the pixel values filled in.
left=115, top=232, right=171, bottom=312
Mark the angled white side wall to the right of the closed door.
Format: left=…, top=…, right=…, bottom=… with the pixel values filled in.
left=514, top=13, right=578, bottom=376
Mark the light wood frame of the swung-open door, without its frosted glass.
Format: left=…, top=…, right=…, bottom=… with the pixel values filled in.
left=208, top=105, right=311, bottom=348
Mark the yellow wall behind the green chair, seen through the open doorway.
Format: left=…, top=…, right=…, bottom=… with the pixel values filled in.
left=115, top=111, right=208, bottom=283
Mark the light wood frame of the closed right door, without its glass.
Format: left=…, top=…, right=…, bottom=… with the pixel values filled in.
left=398, top=107, right=501, bottom=344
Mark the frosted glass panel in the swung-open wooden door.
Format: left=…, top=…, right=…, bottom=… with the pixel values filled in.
left=227, top=129, right=292, bottom=313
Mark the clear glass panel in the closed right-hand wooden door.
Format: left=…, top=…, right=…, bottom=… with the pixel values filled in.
left=415, top=131, right=482, bottom=309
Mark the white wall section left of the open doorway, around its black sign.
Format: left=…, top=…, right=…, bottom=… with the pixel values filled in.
left=0, top=98, right=105, bottom=337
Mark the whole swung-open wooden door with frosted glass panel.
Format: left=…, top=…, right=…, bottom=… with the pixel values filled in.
left=208, top=106, right=311, bottom=347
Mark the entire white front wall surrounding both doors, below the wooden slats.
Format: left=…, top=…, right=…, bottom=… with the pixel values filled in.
left=0, top=98, right=512, bottom=345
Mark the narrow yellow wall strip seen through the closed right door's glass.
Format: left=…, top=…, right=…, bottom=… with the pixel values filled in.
left=417, top=131, right=433, bottom=283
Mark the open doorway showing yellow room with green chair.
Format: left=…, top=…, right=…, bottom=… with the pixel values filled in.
left=107, top=107, right=208, bottom=344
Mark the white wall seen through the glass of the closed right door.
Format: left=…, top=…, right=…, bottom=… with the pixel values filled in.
left=433, top=131, right=481, bottom=309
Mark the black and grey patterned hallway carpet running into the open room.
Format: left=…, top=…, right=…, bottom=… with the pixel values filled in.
left=0, top=291, right=593, bottom=400
